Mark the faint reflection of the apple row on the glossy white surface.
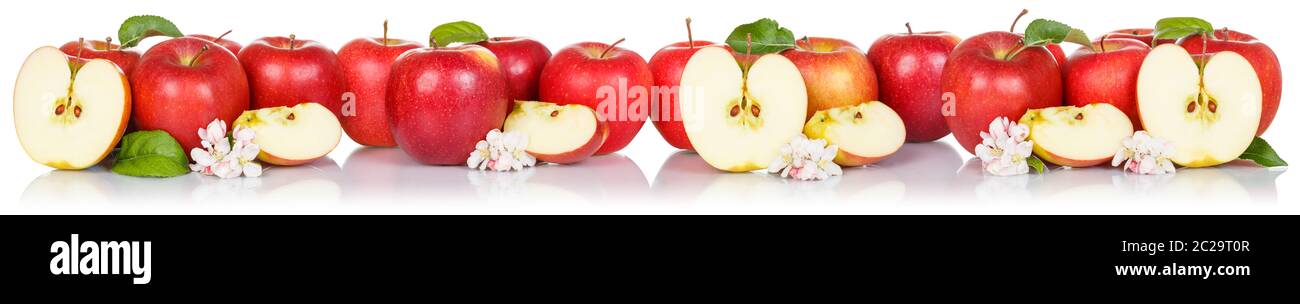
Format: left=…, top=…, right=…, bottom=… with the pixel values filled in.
left=21, top=143, right=1284, bottom=212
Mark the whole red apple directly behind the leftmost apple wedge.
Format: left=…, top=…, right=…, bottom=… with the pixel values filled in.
left=239, top=36, right=347, bottom=118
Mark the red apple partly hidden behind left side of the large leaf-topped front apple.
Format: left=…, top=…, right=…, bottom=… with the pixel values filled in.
left=338, top=38, right=423, bottom=147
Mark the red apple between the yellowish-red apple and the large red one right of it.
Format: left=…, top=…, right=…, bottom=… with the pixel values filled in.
left=867, top=31, right=962, bottom=143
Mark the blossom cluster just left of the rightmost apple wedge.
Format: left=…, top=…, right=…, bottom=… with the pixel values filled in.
left=975, top=117, right=1034, bottom=177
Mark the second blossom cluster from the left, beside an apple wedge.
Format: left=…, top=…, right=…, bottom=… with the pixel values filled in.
left=465, top=129, right=537, bottom=171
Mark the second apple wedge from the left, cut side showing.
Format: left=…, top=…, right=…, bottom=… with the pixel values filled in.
left=503, top=101, right=610, bottom=164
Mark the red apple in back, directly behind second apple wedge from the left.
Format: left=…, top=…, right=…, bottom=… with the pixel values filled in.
left=477, top=36, right=551, bottom=107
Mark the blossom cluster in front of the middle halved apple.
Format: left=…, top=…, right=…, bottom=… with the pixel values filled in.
left=767, top=134, right=844, bottom=181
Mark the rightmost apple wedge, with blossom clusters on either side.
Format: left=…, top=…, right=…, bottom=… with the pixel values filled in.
left=1021, top=104, right=1134, bottom=168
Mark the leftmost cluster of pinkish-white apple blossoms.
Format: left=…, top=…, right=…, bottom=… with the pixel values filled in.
left=190, top=120, right=263, bottom=178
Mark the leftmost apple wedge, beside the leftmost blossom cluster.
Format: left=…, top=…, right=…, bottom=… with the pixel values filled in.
left=234, top=103, right=343, bottom=166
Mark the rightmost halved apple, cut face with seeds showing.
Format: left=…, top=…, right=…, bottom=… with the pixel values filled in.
left=1138, top=44, right=1264, bottom=168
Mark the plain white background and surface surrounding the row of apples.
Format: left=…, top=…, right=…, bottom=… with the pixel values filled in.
left=0, top=0, right=1300, bottom=214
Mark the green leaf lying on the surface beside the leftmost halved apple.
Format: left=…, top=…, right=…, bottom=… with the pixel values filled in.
left=113, top=131, right=190, bottom=177
